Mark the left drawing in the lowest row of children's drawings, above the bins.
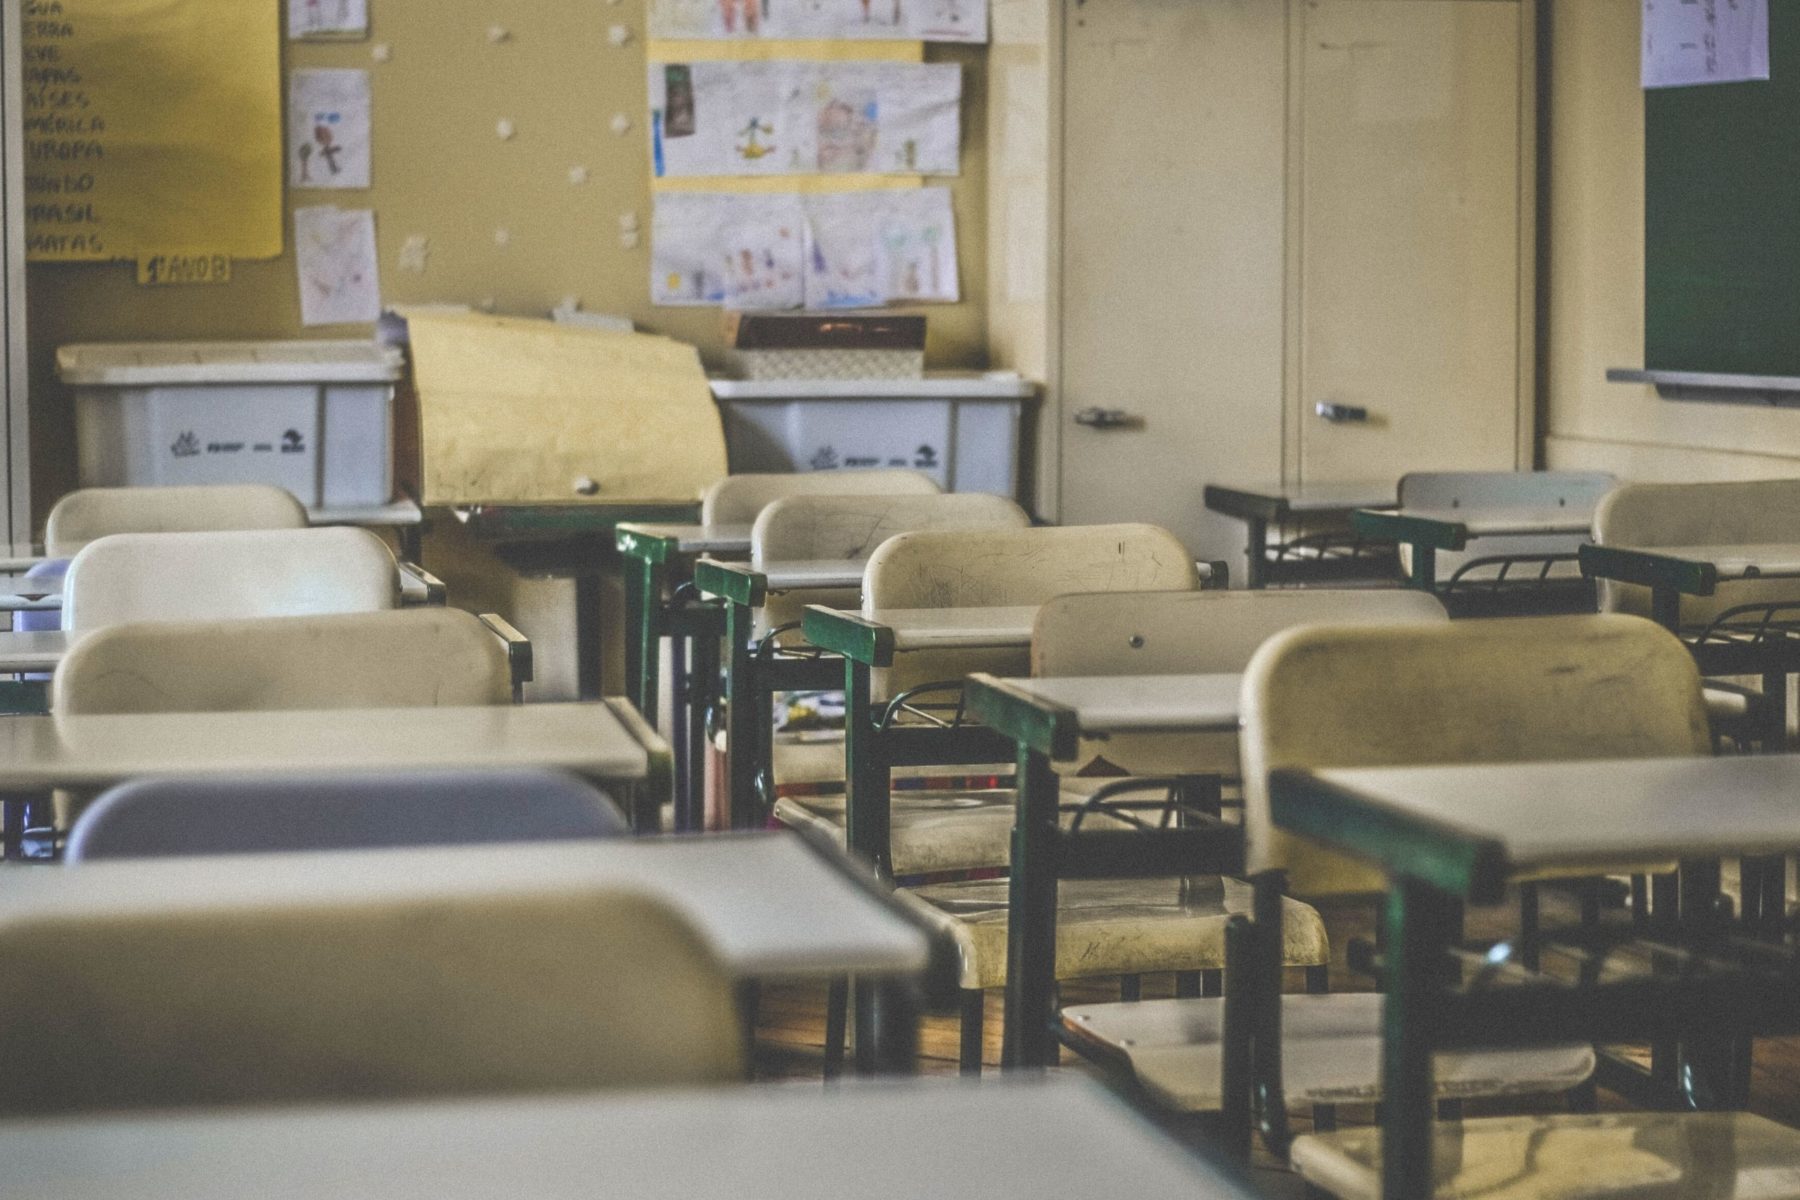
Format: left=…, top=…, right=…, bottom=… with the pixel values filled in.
left=650, top=193, right=806, bottom=308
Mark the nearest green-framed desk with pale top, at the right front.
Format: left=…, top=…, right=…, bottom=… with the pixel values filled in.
left=1269, top=756, right=1800, bottom=1200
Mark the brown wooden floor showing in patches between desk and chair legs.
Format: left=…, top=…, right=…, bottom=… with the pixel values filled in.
left=756, top=892, right=1800, bottom=1196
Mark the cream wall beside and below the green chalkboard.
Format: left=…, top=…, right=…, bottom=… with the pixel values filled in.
left=1544, top=0, right=1800, bottom=479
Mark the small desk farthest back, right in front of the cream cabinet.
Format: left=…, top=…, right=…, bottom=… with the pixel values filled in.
left=1204, top=480, right=1399, bottom=588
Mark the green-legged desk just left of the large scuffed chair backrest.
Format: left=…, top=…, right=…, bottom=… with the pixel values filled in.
left=965, top=675, right=1244, bottom=1067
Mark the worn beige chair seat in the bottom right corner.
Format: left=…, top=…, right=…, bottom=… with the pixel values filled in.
left=1292, top=1112, right=1800, bottom=1200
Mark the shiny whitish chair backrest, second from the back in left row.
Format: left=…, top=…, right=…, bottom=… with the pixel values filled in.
left=63, top=527, right=400, bottom=633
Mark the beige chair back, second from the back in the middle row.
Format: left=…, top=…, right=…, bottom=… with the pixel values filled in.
left=751, top=491, right=1031, bottom=630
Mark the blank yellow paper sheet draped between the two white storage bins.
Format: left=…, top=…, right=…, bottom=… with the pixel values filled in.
left=407, top=313, right=725, bottom=504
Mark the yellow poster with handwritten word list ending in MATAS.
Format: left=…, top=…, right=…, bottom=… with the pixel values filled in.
left=23, top=0, right=283, bottom=261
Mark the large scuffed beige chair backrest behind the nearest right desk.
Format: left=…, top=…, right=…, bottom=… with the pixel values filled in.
left=1242, top=615, right=1712, bottom=896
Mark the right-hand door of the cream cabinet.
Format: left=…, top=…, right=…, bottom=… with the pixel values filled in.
left=1289, top=0, right=1530, bottom=482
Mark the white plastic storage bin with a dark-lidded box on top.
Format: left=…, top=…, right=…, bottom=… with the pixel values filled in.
left=713, top=374, right=1037, bottom=497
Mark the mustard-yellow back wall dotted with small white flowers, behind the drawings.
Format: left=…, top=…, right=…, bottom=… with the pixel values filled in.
left=29, top=0, right=988, bottom=522
